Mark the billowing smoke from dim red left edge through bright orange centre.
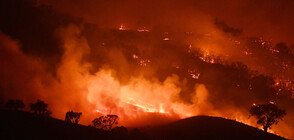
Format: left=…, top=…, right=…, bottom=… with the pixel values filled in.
left=1, top=25, right=217, bottom=126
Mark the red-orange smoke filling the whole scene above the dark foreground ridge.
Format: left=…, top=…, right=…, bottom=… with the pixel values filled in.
left=0, top=0, right=294, bottom=138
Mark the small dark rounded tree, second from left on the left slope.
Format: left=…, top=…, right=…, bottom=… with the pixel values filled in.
left=31, top=100, right=52, bottom=116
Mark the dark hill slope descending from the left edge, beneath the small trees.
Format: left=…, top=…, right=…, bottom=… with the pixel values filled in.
left=0, top=110, right=126, bottom=140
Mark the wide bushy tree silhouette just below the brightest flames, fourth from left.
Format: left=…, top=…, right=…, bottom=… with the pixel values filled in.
left=92, top=115, right=118, bottom=130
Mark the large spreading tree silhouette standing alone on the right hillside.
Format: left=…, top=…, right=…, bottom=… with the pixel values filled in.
left=249, top=103, right=286, bottom=132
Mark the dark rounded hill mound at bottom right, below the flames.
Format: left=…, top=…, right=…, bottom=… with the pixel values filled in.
left=146, top=116, right=284, bottom=140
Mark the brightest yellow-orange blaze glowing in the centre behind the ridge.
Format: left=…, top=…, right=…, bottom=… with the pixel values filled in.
left=88, top=71, right=207, bottom=123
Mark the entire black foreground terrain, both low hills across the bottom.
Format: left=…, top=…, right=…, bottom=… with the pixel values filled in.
left=0, top=110, right=284, bottom=140
